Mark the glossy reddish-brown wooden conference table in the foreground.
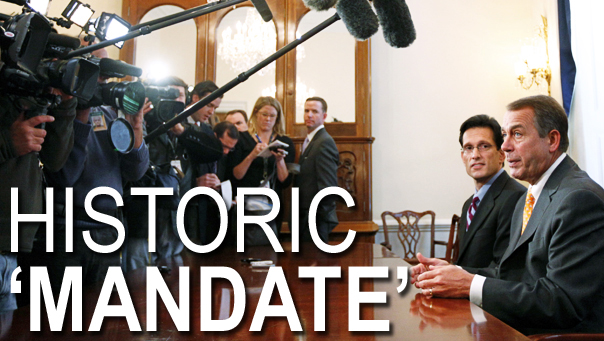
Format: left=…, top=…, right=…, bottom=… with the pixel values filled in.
left=1, top=242, right=527, bottom=341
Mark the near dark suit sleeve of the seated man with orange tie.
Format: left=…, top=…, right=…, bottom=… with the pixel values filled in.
left=483, top=190, right=604, bottom=328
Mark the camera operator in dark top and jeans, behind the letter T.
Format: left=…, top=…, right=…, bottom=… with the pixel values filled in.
left=122, top=76, right=188, bottom=271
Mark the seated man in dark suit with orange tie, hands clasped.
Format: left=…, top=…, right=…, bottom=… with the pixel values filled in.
left=411, top=96, right=604, bottom=334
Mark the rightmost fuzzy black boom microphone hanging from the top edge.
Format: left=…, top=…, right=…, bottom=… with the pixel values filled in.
left=373, top=0, right=415, bottom=47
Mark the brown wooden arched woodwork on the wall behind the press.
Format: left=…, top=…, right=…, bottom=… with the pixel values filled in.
left=120, top=0, right=374, bottom=231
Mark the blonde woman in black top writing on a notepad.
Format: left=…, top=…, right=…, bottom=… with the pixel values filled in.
left=229, top=97, right=296, bottom=245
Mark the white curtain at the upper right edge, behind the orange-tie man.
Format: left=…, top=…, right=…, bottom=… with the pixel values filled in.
left=569, top=0, right=604, bottom=186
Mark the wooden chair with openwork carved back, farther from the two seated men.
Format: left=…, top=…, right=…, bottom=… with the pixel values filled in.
left=382, top=211, right=436, bottom=264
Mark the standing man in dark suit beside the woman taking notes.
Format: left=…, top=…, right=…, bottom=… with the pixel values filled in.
left=294, top=97, right=340, bottom=243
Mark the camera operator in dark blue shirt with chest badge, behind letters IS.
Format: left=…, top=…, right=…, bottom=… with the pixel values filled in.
left=34, top=49, right=150, bottom=294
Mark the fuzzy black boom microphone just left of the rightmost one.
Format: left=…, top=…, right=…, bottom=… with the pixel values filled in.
left=336, top=0, right=378, bottom=40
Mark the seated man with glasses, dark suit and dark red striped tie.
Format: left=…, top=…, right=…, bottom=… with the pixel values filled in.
left=455, top=115, right=526, bottom=268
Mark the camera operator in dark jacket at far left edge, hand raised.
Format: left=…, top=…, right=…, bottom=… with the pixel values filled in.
left=0, top=89, right=77, bottom=312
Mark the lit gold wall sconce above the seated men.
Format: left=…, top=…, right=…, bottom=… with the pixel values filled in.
left=514, top=16, right=552, bottom=96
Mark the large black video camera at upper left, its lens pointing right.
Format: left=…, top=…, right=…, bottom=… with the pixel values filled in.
left=0, top=0, right=145, bottom=115
